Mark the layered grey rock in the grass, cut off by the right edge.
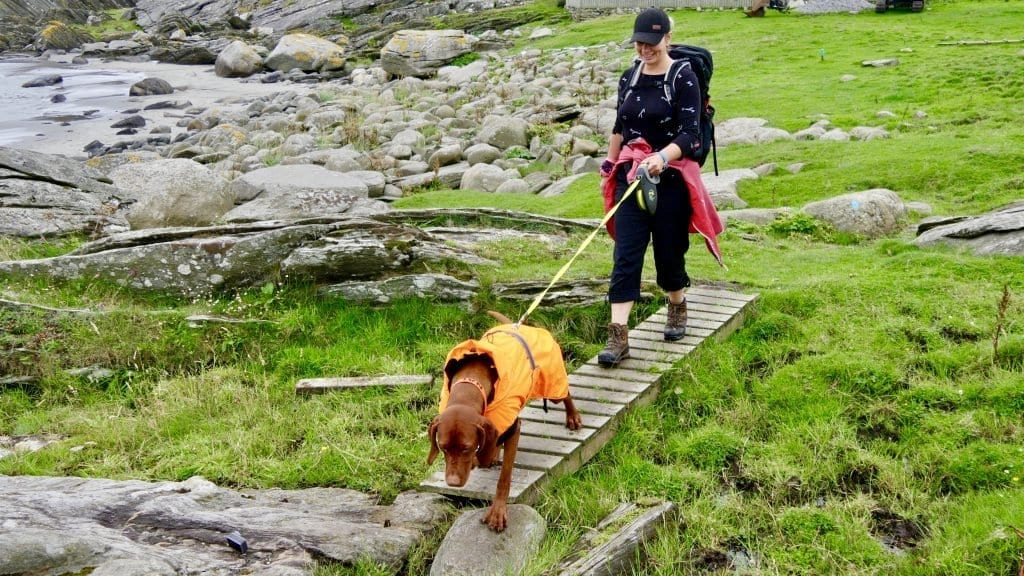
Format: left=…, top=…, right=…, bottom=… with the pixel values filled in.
left=914, top=202, right=1024, bottom=256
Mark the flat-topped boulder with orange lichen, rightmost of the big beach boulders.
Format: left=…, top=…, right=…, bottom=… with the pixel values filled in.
left=381, top=30, right=476, bottom=78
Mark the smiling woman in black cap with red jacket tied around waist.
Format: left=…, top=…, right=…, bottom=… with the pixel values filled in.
left=598, top=7, right=722, bottom=367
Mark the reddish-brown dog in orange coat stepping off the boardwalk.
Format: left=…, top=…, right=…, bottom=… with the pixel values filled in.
left=427, top=312, right=583, bottom=532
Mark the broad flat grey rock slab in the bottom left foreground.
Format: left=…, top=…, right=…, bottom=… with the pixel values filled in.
left=0, top=476, right=451, bottom=576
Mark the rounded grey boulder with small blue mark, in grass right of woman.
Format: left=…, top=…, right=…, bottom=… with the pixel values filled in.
left=803, top=189, right=906, bottom=238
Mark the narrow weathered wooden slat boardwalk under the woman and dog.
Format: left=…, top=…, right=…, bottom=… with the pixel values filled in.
left=420, top=288, right=758, bottom=504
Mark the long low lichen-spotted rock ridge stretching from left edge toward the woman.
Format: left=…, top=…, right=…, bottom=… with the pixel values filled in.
left=0, top=217, right=493, bottom=297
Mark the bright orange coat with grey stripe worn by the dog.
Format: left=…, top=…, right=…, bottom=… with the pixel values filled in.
left=439, top=324, right=569, bottom=435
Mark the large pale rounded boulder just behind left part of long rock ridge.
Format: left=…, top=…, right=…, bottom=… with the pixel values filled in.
left=111, top=159, right=234, bottom=230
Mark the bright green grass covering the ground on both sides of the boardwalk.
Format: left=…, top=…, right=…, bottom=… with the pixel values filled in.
left=0, top=0, right=1024, bottom=576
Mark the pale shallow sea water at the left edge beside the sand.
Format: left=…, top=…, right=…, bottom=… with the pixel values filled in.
left=0, top=57, right=145, bottom=148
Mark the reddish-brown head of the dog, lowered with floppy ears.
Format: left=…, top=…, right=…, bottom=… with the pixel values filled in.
left=427, top=406, right=498, bottom=488
